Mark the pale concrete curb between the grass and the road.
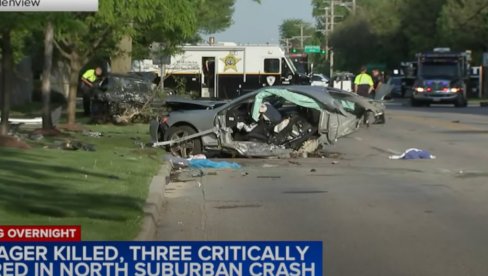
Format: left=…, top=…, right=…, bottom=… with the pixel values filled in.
left=134, top=163, right=171, bottom=241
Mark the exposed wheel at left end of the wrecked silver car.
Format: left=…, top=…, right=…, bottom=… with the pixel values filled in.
left=168, top=126, right=202, bottom=158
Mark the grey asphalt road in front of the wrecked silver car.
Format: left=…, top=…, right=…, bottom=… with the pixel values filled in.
left=158, top=103, right=488, bottom=276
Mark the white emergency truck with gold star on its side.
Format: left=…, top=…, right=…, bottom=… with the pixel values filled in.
left=134, top=43, right=310, bottom=99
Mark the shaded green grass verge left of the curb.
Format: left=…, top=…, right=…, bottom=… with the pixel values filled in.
left=0, top=124, right=162, bottom=240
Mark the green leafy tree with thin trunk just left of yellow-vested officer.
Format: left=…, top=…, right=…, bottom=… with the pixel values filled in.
left=55, top=0, right=201, bottom=124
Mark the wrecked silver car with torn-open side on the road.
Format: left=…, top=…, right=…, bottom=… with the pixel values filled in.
left=150, top=86, right=384, bottom=157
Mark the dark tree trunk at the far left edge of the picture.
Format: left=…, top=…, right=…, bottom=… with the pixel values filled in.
left=0, top=29, right=14, bottom=135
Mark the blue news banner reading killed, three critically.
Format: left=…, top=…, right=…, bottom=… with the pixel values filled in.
left=0, top=241, right=323, bottom=276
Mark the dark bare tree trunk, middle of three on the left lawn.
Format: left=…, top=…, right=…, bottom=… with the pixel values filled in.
left=42, top=21, right=54, bottom=129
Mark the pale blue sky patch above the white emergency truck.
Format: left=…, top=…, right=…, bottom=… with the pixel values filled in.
left=210, top=0, right=315, bottom=44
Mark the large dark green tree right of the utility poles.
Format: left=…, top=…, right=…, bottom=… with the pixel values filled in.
left=312, top=0, right=446, bottom=71
